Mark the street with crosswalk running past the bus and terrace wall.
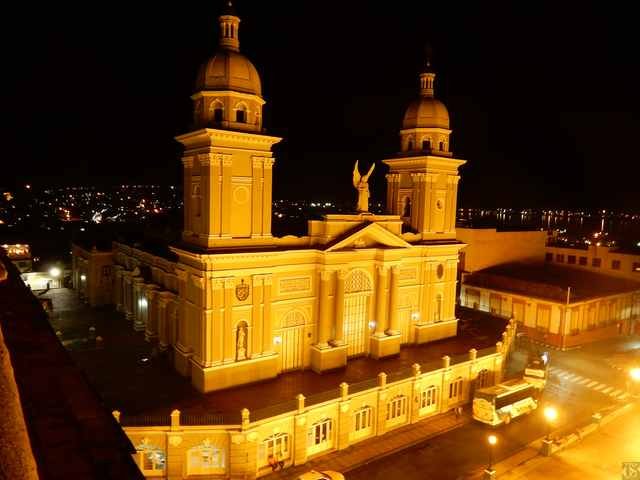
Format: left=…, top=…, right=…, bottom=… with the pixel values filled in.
left=346, top=341, right=633, bottom=480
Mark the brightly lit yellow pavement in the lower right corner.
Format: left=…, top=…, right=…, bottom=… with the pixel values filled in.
left=488, top=405, right=640, bottom=480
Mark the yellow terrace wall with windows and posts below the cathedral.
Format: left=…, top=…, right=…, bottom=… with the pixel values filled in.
left=119, top=322, right=516, bottom=480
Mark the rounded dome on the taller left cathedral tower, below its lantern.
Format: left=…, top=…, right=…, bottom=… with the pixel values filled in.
left=196, top=49, right=262, bottom=96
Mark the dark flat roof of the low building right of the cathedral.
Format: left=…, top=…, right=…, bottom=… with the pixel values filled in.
left=464, top=263, right=640, bottom=303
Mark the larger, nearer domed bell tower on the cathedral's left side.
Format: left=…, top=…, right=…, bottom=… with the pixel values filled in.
left=176, top=1, right=281, bottom=248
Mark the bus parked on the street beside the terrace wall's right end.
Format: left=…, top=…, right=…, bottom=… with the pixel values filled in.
left=473, top=379, right=539, bottom=425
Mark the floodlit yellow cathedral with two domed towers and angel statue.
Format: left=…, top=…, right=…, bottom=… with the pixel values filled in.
left=73, top=4, right=465, bottom=392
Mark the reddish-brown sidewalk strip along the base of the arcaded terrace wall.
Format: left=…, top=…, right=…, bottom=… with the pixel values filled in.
left=261, top=411, right=471, bottom=480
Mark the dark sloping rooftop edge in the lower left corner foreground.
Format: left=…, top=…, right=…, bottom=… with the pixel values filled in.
left=0, top=257, right=144, bottom=480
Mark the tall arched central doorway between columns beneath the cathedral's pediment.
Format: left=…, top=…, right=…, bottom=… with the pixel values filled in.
left=344, top=270, right=372, bottom=357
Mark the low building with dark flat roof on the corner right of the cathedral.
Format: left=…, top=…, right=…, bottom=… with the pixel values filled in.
left=460, top=263, right=640, bottom=349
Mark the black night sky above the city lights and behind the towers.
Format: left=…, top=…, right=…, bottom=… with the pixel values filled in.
left=0, top=0, right=640, bottom=211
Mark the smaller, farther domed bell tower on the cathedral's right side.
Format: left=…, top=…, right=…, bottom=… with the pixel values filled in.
left=384, top=55, right=465, bottom=240
